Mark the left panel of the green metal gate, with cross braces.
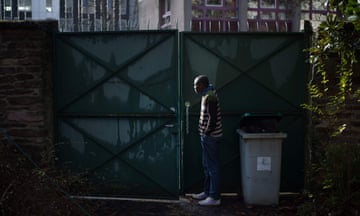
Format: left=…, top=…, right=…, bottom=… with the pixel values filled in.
left=54, top=31, right=180, bottom=199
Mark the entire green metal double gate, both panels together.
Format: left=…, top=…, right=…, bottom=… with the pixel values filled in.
left=54, top=31, right=307, bottom=199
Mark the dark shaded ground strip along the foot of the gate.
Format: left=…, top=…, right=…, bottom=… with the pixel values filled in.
left=92, top=195, right=301, bottom=216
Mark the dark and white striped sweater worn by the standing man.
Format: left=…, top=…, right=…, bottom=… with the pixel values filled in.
left=199, top=86, right=222, bottom=137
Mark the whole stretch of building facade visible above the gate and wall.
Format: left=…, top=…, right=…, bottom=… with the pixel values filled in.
left=0, top=0, right=336, bottom=32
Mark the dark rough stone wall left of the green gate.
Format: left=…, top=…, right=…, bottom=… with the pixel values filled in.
left=0, top=21, right=57, bottom=159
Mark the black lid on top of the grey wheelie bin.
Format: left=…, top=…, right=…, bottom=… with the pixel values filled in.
left=239, top=112, right=282, bottom=133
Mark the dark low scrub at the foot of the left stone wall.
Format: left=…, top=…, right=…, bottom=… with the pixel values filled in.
left=0, top=139, right=97, bottom=216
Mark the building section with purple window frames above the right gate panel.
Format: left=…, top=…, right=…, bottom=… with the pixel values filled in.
left=191, top=0, right=336, bottom=32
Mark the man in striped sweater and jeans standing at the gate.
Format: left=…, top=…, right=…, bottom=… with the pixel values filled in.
left=193, top=75, right=222, bottom=206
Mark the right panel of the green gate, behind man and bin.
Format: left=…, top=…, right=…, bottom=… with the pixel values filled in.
left=181, top=33, right=307, bottom=192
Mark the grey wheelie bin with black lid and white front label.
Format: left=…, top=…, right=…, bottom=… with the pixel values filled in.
left=237, top=113, right=287, bottom=205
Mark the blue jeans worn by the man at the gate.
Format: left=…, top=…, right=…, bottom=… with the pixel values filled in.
left=200, top=135, right=220, bottom=199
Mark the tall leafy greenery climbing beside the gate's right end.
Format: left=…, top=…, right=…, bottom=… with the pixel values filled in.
left=299, top=0, right=360, bottom=215
